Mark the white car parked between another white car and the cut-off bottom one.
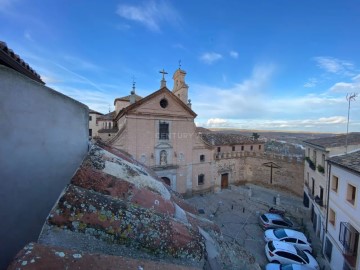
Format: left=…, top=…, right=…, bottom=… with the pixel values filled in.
left=265, top=241, right=320, bottom=270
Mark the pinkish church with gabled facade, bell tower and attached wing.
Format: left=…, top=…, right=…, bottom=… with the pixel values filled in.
left=89, top=68, right=264, bottom=195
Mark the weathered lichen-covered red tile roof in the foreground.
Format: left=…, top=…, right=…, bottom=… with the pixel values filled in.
left=23, top=144, right=220, bottom=269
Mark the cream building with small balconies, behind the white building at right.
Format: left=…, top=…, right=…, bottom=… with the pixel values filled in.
left=304, top=133, right=360, bottom=249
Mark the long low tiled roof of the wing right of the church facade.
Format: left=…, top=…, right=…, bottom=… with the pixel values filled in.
left=199, top=132, right=263, bottom=146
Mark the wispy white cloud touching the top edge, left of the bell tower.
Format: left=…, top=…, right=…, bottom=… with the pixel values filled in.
left=116, top=1, right=180, bottom=32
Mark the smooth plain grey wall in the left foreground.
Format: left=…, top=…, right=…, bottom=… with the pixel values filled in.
left=0, top=65, right=89, bottom=269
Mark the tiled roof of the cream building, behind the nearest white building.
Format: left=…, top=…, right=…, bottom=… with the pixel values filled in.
left=304, top=132, right=360, bottom=148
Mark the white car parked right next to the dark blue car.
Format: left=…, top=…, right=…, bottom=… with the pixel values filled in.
left=264, top=229, right=312, bottom=253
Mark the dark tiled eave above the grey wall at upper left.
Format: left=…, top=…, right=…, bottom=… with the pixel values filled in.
left=0, top=41, right=45, bottom=84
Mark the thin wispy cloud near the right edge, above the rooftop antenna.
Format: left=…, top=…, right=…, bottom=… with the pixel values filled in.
left=314, top=56, right=355, bottom=76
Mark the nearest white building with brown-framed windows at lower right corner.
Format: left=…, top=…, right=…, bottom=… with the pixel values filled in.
left=323, top=151, right=360, bottom=270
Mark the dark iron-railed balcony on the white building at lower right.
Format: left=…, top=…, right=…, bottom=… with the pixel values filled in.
left=339, top=222, right=359, bottom=268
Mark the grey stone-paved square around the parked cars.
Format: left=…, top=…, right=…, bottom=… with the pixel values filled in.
left=187, top=184, right=326, bottom=269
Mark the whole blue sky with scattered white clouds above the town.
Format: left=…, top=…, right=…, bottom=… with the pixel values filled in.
left=0, top=0, right=360, bottom=132
